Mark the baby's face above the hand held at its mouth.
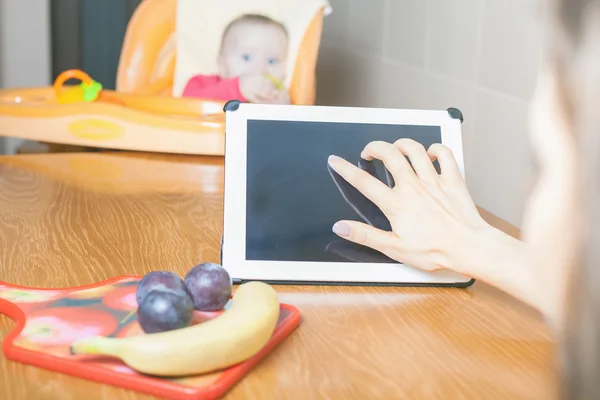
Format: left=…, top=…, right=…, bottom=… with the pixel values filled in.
left=218, top=22, right=287, bottom=81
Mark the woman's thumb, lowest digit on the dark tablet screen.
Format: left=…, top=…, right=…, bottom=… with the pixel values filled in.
left=332, top=221, right=400, bottom=259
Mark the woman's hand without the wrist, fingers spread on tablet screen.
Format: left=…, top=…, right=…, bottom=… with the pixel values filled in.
left=329, top=139, right=490, bottom=271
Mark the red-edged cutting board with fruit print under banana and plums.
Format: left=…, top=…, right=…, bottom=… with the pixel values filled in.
left=0, top=276, right=300, bottom=400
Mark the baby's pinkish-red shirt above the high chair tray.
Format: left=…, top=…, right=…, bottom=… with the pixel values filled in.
left=182, top=75, right=246, bottom=102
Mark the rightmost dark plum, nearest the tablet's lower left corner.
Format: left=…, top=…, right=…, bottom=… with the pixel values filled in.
left=183, top=262, right=232, bottom=311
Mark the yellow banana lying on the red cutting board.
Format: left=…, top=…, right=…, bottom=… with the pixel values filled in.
left=71, top=282, right=279, bottom=377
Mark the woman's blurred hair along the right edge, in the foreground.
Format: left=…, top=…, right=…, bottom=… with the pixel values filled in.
left=547, top=0, right=600, bottom=400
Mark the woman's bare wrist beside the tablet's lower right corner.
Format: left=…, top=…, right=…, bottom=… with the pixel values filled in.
left=457, top=226, right=542, bottom=311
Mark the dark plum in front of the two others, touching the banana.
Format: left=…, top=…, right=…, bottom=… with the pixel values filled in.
left=137, top=289, right=194, bottom=333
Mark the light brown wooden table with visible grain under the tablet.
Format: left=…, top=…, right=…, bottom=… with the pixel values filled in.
left=0, top=153, right=555, bottom=400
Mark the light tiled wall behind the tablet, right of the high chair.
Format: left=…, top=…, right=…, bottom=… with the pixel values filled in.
left=317, top=0, right=541, bottom=225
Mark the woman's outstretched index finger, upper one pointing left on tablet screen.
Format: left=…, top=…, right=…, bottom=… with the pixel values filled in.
left=327, top=155, right=393, bottom=214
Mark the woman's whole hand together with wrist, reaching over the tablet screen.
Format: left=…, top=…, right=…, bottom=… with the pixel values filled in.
left=329, top=139, right=540, bottom=308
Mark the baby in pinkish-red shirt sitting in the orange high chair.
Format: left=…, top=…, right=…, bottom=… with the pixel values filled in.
left=183, top=14, right=290, bottom=104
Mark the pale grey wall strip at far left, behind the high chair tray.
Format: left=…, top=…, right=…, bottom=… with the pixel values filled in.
left=0, top=0, right=52, bottom=154
